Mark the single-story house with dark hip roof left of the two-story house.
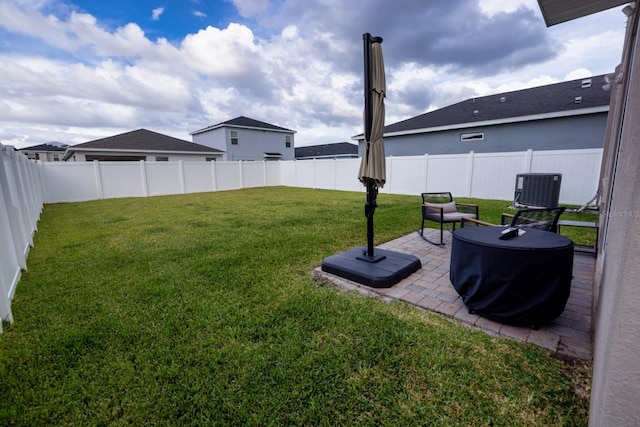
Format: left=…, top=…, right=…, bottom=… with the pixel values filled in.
left=63, top=129, right=224, bottom=162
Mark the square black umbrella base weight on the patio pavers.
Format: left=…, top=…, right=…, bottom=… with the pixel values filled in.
left=322, top=247, right=422, bottom=288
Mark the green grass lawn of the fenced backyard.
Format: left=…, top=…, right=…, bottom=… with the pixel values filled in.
left=0, top=187, right=590, bottom=426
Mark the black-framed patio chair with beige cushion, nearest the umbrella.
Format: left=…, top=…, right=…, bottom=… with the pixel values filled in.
left=418, top=192, right=479, bottom=246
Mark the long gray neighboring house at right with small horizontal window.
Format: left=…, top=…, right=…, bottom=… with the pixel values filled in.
left=353, top=76, right=611, bottom=156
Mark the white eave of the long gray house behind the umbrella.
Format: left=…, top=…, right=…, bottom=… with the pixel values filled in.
left=351, top=105, right=609, bottom=141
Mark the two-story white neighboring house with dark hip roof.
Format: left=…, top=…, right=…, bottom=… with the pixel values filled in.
left=190, top=116, right=296, bottom=161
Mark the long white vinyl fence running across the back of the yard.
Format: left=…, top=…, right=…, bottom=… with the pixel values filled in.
left=39, top=149, right=602, bottom=204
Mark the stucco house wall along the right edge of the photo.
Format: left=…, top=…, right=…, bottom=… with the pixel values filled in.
left=589, top=10, right=640, bottom=426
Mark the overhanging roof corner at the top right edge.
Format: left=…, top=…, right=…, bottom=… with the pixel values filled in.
left=538, top=0, right=629, bottom=27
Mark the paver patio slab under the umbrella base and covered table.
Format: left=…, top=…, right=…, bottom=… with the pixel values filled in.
left=314, top=229, right=595, bottom=360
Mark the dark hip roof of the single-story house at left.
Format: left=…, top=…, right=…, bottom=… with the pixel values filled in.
left=64, top=129, right=223, bottom=160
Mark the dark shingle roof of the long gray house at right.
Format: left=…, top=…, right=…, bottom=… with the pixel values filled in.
left=353, top=75, right=611, bottom=139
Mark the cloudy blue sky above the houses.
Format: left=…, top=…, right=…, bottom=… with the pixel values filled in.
left=0, top=0, right=626, bottom=147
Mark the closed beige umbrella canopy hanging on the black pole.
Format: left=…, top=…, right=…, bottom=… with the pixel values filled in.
left=358, top=40, right=387, bottom=188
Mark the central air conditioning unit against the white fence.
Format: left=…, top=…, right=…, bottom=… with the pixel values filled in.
left=513, top=173, right=562, bottom=208
